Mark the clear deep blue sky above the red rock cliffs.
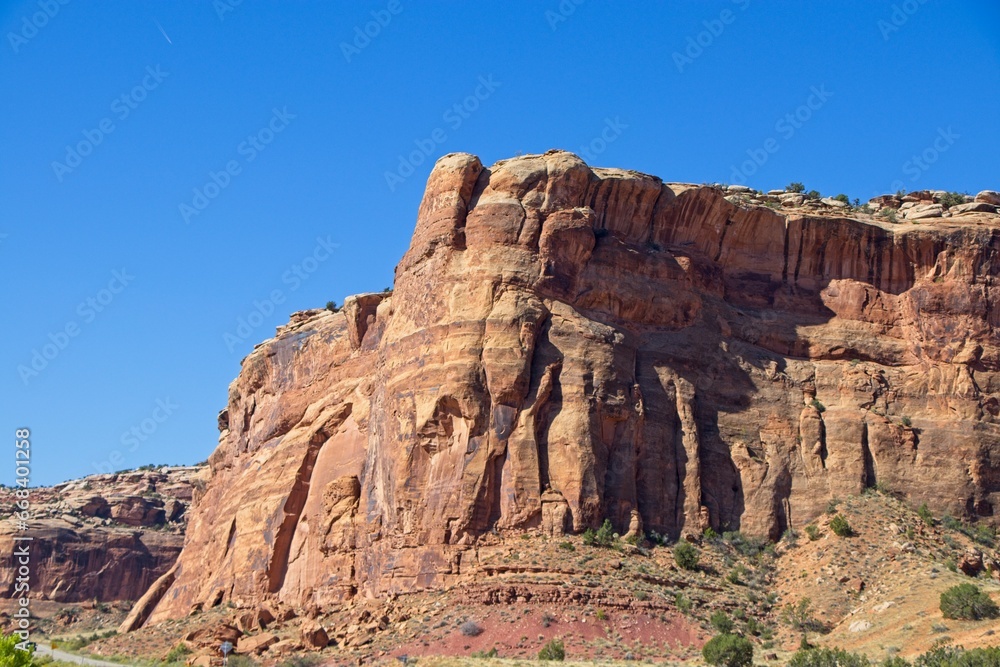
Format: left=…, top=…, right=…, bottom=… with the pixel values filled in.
left=0, top=0, right=1000, bottom=484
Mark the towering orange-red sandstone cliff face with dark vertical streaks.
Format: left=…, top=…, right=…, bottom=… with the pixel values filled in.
left=139, top=152, right=1000, bottom=626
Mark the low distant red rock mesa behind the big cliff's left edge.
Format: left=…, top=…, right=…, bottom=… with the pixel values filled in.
left=0, top=467, right=207, bottom=602
